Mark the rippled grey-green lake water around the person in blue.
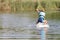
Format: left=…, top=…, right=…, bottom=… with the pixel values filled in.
left=0, top=11, right=60, bottom=40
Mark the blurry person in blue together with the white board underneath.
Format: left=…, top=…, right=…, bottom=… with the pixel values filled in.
left=36, top=9, right=49, bottom=32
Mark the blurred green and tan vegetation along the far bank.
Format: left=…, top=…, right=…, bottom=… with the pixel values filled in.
left=0, top=0, right=60, bottom=12
